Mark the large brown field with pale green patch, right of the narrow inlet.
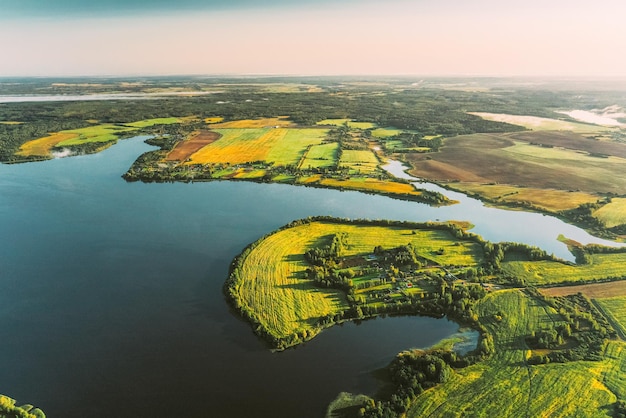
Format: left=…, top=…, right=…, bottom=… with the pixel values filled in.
left=407, top=132, right=626, bottom=194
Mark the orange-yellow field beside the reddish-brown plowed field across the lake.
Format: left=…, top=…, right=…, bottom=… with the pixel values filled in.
left=188, top=128, right=288, bottom=164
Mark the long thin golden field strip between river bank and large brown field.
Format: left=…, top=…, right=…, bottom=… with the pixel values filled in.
left=448, top=182, right=598, bottom=211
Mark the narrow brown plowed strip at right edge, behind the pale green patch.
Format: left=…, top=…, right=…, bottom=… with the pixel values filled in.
left=509, top=131, right=626, bottom=158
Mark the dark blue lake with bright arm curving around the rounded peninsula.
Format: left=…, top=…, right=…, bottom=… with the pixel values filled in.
left=0, top=138, right=620, bottom=418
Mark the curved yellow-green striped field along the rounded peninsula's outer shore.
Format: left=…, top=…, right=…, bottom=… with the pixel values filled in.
left=232, top=221, right=482, bottom=338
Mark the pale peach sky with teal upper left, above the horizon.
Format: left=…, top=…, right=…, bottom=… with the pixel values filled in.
left=0, top=0, right=626, bottom=77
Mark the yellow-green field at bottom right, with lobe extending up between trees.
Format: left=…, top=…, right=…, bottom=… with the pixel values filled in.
left=407, top=290, right=616, bottom=418
